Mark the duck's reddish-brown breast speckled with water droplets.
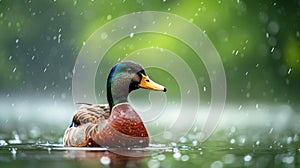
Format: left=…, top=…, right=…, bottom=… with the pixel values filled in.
left=93, top=103, right=149, bottom=147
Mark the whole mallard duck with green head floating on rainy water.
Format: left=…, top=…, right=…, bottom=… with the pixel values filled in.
left=63, top=61, right=167, bottom=148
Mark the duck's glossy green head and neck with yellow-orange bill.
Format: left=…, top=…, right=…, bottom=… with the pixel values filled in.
left=107, top=61, right=167, bottom=108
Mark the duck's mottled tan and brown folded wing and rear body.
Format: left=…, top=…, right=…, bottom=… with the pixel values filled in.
left=64, top=103, right=110, bottom=146
